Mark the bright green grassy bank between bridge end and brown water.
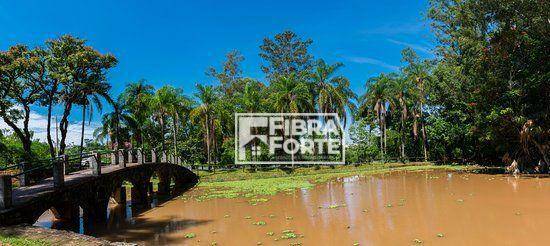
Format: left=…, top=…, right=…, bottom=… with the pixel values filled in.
left=193, top=163, right=477, bottom=201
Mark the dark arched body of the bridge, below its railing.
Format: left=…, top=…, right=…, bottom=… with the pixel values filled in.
left=0, top=155, right=198, bottom=226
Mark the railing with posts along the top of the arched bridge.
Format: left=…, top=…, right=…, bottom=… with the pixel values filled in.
left=0, top=148, right=181, bottom=209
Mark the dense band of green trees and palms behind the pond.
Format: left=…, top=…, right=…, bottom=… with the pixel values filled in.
left=0, top=0, right=550, bottom=172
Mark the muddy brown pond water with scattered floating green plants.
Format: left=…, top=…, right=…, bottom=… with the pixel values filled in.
left=38, top=171, right=550, bottom=245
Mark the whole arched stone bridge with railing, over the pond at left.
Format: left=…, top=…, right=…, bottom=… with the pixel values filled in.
left=0, top=149, right=198, bottom=226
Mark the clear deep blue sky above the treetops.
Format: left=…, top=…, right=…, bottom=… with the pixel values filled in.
left=0, top=0, right=440, bottom=143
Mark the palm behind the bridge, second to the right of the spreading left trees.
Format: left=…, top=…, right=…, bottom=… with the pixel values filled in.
left=119, top=80, right=154, bottom=148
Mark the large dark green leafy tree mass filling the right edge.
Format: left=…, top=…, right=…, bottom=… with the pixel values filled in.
left=428, top=0, right=550, bottom=166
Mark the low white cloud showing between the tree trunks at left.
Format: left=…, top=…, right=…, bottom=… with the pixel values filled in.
left=0, top=111, right=101, bottom=145
